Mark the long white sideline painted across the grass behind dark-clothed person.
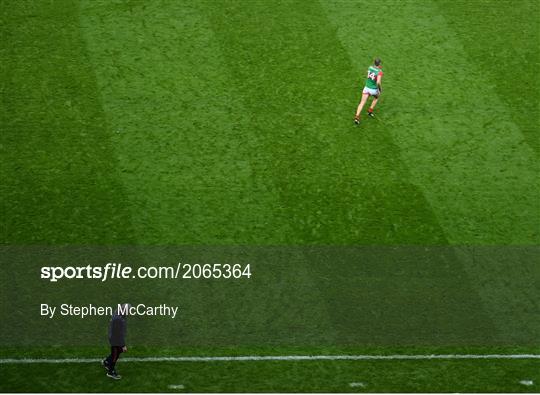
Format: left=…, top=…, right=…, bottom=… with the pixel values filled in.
left=0, top=354, right=540, bottom=364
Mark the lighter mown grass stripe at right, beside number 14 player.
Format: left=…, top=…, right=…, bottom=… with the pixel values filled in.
left=321, top=0, right=540, bottom=245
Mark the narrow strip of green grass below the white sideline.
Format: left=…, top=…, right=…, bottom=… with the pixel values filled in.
left=2, top=350, right=540, bottom=392
